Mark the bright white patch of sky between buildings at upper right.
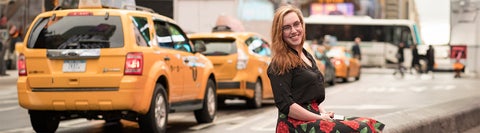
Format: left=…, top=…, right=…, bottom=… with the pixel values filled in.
left=414, top=0, right=450, bottom=44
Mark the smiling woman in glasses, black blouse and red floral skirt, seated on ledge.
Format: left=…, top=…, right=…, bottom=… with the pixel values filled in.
left=267, top=5, right=385, bottom=133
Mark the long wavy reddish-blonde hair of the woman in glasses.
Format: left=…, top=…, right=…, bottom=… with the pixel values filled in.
left=270, top=5, right=306, bottom=75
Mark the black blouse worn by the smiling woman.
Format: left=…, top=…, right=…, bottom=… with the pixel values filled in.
left=268, top=49, right=325, bottom=115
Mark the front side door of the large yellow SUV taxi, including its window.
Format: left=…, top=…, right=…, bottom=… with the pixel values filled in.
left=167, top=23, right=201, bottom=100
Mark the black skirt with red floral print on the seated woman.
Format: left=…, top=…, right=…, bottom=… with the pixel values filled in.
left=276, top=102, right=385, bottom=133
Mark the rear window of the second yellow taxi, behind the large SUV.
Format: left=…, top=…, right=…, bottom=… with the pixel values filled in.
left=190, top=38, right=237, bottom=56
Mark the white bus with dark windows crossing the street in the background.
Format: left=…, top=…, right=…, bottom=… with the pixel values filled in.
left=305, top=16, right=423, bottom=68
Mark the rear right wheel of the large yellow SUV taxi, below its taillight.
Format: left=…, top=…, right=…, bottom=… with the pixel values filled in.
left=138, top=84, right=168, bottom=133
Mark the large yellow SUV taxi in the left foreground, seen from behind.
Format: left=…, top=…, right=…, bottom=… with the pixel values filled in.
left=16, top=0, right=216, bottom=132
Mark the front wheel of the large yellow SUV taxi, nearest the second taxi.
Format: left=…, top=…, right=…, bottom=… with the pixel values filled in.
left=194, top=79, right=217, bottom=123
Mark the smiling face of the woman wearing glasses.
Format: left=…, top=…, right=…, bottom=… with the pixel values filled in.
left=282, top=12, right=303, bottom=48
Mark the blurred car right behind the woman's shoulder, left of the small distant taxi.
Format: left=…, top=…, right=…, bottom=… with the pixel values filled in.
left=303, top=42, right=336, bottom=85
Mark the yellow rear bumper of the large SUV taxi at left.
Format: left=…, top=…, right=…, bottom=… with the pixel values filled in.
left=17, top=77, right=153, bottom=113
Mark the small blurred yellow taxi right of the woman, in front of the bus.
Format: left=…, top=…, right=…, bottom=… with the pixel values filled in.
left=326, top=46, right=361, bottom=82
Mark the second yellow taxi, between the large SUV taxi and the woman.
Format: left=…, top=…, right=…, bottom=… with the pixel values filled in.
left=188, top=26, right=273, bottom=108
